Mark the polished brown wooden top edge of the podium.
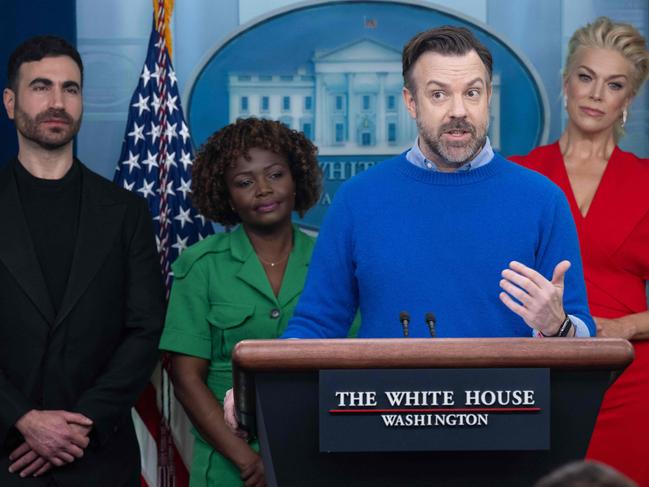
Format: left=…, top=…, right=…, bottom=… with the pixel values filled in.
left=232, top=338, right=634, bottom=372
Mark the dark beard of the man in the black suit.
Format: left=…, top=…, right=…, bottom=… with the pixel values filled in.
left=14, top=104, right=81, bottom=150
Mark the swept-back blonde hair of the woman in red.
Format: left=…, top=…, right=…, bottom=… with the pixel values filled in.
left=563, top=17, right=649, bottom=140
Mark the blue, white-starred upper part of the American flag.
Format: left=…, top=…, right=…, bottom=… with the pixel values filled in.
left=114, top=29, right=212, bottom=287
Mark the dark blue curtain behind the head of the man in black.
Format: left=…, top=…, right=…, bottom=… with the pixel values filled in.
left=0, top=0, right=77, bottom=167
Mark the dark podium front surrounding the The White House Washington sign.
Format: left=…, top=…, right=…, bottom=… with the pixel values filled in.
left=255, top=370, right=611, bottom=487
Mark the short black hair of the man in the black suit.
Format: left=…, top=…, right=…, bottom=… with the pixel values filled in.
left=7, top=35, right=83, bottom=91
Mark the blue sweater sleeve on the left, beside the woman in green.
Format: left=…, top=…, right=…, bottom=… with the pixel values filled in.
left=282, top=187, right=358, bottom=338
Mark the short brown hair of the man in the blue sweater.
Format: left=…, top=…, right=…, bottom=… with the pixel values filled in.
left=402, top=25, right=493, bottom=94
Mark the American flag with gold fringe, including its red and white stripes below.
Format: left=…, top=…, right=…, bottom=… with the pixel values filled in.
left=114, top=0, right=213, bottom=487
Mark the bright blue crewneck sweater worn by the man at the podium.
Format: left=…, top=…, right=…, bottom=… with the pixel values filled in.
left=283, top=154, right=594, bottom=338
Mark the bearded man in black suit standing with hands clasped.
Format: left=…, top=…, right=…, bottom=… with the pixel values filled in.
left=0, top=36, right=164, bottom=487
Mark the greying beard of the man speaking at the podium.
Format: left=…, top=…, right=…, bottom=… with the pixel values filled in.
left=416, top=118, right=489, bottom=169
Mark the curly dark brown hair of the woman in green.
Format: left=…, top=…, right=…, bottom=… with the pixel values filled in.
left=192, top=117, right=322, bottom=226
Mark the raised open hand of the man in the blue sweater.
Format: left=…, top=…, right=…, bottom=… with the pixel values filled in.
left=499, top=260, right=570, bottom=336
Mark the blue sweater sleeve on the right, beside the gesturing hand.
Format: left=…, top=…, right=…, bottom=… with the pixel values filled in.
left=537, top=189, right=595, bottom=336
